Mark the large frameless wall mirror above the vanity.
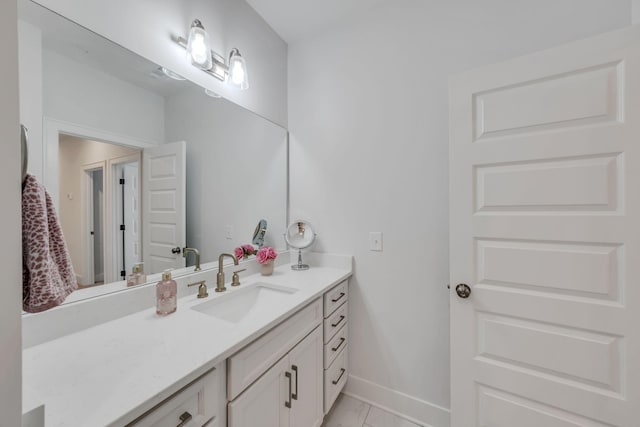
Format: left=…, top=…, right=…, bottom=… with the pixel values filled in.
left=19, top=0, right=288, bottom=310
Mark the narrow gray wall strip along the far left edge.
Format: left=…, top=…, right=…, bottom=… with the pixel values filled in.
left=0, top=0, right=22, bottom=427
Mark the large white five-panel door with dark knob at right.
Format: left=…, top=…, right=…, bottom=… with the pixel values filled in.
left=450, top=28, right=640, bottom=427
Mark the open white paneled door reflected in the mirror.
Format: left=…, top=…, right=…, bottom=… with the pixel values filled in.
left=142, top=141, right=186, bottom=274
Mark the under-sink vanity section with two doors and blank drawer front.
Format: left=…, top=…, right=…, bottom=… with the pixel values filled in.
left=227, top=299, right=324, bottom=427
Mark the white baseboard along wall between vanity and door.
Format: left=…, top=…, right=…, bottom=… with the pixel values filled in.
left=342, top=375, right=450, bottom=427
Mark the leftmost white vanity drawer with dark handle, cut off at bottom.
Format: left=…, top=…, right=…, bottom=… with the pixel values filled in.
left=127, top=365, right=226, bottom=427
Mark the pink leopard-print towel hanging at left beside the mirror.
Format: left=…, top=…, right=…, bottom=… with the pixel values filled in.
left=22, top=175, right=78, bottom=313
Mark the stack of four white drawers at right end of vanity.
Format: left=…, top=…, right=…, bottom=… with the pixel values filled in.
left=323, top=280, right=349, bottom=414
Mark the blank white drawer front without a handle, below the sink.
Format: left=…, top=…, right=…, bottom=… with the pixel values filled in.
left=227, top=298, right=322, bottom=401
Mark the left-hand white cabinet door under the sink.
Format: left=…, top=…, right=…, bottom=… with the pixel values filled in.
left=228, top=357, right=291, bottom=427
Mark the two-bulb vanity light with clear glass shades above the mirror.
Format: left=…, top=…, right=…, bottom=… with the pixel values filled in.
left=174, top=19, right=249, bottom=90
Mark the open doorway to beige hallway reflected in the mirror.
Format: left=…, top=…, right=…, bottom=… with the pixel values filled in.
left=58, top=133, right=142, bottom=288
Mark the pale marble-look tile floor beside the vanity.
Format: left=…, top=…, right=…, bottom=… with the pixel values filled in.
left=322, top=394, right=421, bottom=427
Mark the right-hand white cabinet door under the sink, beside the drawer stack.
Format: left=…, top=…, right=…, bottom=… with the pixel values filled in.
left=288, top=327, right=324, bottom=427
